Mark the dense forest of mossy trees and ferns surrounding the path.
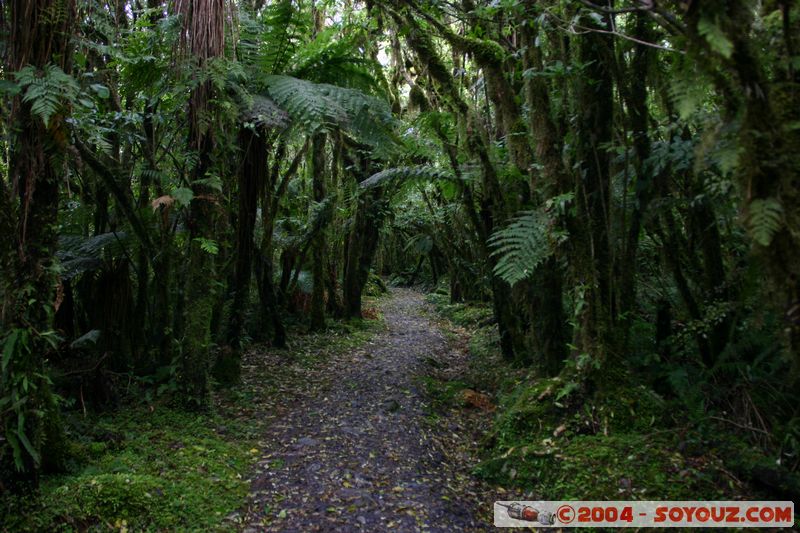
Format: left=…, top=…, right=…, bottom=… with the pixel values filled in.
left=0, top=0, right=800, bottom=529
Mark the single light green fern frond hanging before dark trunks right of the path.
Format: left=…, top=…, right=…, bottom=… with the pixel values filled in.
left=489, top=210, right=566, bottom=285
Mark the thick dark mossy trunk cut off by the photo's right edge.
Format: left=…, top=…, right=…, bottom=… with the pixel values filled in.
left=685, top=0, right=800, bottom=364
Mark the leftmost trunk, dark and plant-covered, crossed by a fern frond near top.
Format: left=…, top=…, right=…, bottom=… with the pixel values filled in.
left=0, top=0, right=75, bottom=492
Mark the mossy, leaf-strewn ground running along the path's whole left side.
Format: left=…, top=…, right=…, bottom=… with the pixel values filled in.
left=0, top=306, right=382, bottom=532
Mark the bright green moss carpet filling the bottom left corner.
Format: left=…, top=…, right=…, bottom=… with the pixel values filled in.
left=0, top=408, right=256, bottom=531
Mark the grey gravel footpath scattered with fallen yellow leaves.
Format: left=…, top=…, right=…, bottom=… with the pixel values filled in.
left=238, top=289, right=494, bottom=532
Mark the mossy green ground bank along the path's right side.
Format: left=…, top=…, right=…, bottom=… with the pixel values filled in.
left=426, top=294, right=780, bottom=500
